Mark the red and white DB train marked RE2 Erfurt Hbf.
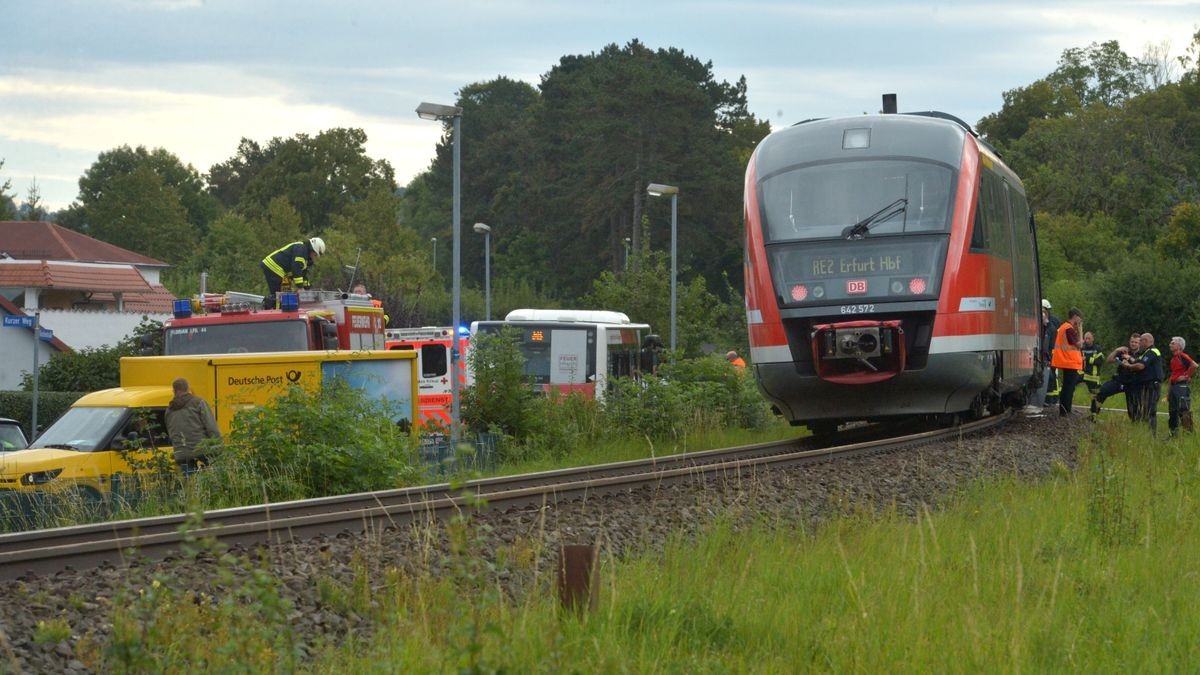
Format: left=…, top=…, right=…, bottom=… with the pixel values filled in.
left=745, top=101, right=1043, bottom=432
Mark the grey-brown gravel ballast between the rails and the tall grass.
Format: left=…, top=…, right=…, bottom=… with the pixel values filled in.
left=0, top=417, right=1087, bottom=673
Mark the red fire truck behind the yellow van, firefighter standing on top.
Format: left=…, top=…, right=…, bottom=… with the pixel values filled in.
left=163, top=291, right=384, bottom=356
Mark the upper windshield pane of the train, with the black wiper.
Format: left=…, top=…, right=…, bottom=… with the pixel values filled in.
left=758, top=160, right=955, bottom=243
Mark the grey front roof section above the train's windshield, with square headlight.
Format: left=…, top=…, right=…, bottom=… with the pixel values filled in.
left=755, top=113, right=973, bottom=180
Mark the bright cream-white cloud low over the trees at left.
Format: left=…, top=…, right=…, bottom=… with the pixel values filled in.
left=0, top=66, right=442, bottom=208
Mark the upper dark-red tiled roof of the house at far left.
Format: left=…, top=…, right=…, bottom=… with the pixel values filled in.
left=0, top=220, right=169, bottom=267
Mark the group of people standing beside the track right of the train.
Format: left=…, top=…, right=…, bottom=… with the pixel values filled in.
left=1034, top=300, right=1196, bottom=436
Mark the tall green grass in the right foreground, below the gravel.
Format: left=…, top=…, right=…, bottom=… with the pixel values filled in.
left=313, top=422, right=1200, bottom=673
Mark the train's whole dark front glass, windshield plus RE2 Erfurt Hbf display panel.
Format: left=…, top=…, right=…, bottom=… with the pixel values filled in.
left=760, top=159, right=956, bottom=313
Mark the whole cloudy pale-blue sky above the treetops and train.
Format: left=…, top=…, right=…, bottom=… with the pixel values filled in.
left=0, top=0, right=1200, bottom=210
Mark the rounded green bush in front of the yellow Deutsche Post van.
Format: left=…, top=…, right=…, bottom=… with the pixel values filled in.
left=211, top=380, right=420, bottom=503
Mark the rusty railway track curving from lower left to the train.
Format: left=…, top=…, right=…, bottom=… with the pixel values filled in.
left=0, top=414, right=1010, bottom=580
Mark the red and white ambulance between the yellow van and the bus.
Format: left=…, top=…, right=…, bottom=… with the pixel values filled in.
left=385, top=325, right=472, bottom=426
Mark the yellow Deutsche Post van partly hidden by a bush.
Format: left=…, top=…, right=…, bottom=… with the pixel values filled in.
left=0, top=351, right=418, bottom=497
